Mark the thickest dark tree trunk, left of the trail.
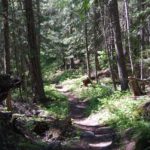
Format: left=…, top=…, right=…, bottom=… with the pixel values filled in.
left=24, top=0, right=46, bottom=102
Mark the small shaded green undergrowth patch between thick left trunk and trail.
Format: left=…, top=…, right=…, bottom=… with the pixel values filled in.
left=45, top=85, right=68, bottom=118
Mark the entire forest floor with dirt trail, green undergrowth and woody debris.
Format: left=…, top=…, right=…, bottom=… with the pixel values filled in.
left=0, top=71, right=150, bottom=150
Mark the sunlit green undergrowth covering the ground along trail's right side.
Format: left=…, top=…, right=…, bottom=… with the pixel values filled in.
left=60, top=75, right=150, bottom=141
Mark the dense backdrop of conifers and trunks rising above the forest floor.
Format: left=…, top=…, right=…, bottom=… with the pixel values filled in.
left=0, top=0, right=149, bottom=96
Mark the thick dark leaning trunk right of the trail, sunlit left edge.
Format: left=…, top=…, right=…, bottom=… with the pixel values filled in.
left=108, top=0, right=128, bottom=90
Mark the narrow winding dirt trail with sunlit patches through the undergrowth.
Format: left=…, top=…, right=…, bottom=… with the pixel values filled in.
left=56, top=85, right=117, bottom=150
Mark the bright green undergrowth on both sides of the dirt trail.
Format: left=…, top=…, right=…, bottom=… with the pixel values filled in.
left=45, top=69, right=150, bottom=144
